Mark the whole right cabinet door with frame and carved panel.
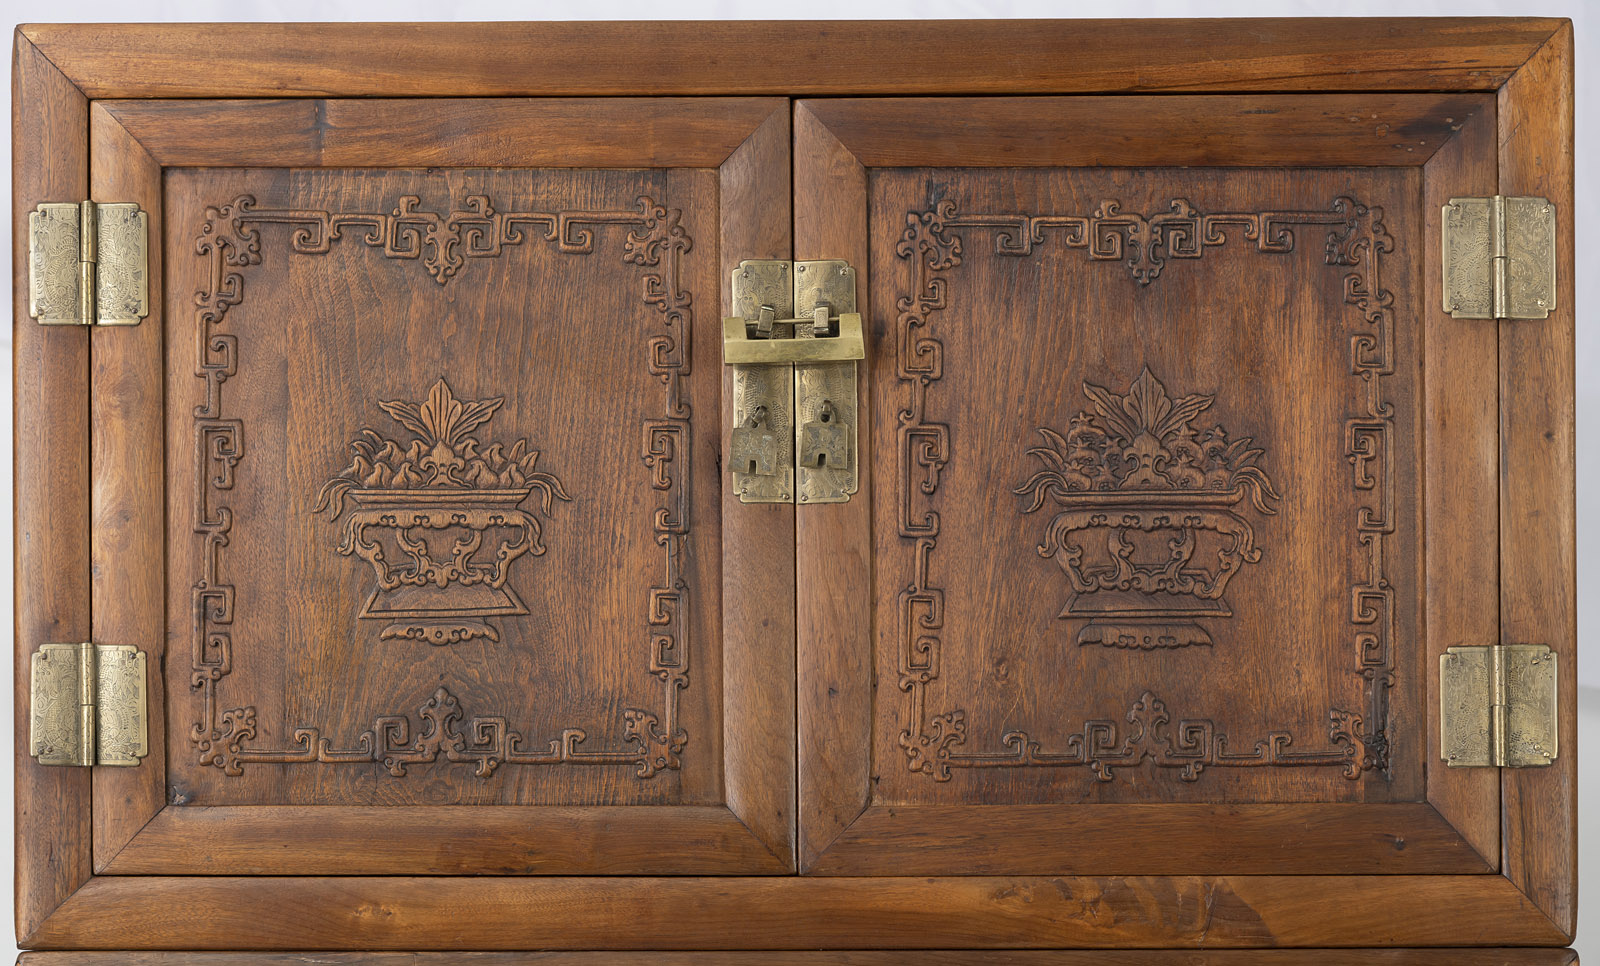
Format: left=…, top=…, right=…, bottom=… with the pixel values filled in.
left=795, top=94, right=1570, bottom=907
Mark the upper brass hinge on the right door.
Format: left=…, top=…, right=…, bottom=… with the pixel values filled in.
left=1442, top=195, right=1555, bottom=318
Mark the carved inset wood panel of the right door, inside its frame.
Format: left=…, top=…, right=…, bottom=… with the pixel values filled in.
left=872, top=170, right=1424, bottom=803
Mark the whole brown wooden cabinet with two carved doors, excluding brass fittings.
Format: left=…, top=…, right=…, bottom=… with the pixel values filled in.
left=14, top=19, right=1576, bottom=966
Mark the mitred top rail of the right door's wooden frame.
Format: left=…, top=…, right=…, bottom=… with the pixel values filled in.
left=805, top=93, right=1493, bottom=168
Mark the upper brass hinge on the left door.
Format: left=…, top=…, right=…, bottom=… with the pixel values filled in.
left=27, top=202, right=150, bottom=325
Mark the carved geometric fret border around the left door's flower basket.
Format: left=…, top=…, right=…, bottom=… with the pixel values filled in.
left=190, top=195, right=691, bottom=779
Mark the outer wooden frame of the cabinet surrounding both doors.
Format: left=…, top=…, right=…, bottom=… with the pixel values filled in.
left=13, top=18, right=1576, bottom=950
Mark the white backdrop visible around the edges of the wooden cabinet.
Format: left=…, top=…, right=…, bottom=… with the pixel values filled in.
left=0, top=0, right=1600, bottom=960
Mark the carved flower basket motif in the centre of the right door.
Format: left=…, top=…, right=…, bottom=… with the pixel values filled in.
left=1014, top=368, right=1280, bottom=649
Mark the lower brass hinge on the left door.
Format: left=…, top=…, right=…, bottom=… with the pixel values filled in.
left=29, top=643, right=150, bottom=766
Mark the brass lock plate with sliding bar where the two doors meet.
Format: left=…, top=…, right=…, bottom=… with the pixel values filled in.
left=722, top=261, right=867, bottom=504
